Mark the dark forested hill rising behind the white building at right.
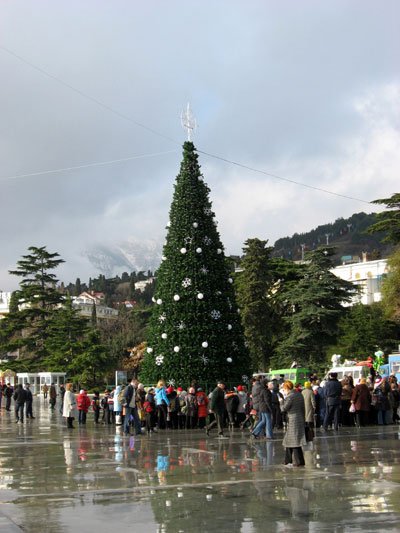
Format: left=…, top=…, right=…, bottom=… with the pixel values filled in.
left=273, top=213, right=393, bottom=264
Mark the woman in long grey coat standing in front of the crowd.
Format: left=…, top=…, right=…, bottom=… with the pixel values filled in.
left=281, top=381, right=307, bottom=466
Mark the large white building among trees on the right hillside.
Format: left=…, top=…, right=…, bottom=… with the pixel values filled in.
left=332, top=259, right=388, bottom=305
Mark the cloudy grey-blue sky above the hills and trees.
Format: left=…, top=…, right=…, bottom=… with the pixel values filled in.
left=0, top=0, right=400, bottom=290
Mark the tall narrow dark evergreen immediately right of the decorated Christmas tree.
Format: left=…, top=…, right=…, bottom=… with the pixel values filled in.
left=235, top=239, right=273, bottom=370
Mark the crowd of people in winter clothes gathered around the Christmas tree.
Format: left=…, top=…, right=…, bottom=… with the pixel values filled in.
left=0, top=373, right=400, bottom=466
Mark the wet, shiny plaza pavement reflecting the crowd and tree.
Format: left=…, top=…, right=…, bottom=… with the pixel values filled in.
left=0, top=399, right=400, bottom=533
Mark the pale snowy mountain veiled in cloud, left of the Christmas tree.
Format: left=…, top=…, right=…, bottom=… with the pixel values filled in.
left=83, top=238, right=162, bottom=278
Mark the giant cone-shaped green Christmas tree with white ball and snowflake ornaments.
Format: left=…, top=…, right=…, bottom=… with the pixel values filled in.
left=140, top=141, right=249, bottom=385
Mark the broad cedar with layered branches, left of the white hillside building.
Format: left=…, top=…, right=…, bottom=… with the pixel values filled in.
left=276, top=248, right=356, bottom=366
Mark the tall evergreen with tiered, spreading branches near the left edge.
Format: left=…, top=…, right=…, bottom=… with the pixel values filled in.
left=4, top=246, right=64, bottom=362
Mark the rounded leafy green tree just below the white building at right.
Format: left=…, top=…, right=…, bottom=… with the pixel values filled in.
left=329, top=302, right=400, bottom=360
